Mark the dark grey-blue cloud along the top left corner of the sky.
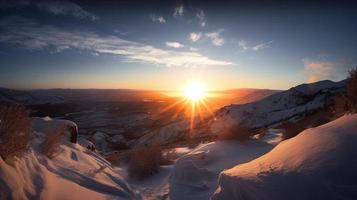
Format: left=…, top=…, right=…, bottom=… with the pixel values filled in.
left=0, top=0, right=99, bottom=20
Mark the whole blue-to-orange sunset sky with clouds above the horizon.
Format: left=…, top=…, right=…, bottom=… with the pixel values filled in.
left=0, top=0, right=357, bottom=90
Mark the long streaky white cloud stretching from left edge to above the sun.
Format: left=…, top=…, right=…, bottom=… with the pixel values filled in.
left=0, top=18, right=233, bottom=67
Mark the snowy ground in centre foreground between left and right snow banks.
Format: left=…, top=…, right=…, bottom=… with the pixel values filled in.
left=101, top=129, right=281, bottom=200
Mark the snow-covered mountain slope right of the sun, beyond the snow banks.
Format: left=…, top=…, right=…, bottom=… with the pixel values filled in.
left=211, top=81, right=345, bottom=134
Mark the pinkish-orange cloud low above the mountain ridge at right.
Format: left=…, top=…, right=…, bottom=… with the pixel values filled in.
left=303, top=55, right=350, bottom=83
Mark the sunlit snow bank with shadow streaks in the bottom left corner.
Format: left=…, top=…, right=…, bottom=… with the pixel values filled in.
left=0, top=143, right=140, bottom=200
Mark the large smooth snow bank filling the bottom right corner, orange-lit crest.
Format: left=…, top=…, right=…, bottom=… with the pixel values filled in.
left=213, top=114, right=357, bottom=200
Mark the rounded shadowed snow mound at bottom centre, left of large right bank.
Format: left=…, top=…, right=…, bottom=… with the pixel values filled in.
left=169, top=140, right=273, bottom=200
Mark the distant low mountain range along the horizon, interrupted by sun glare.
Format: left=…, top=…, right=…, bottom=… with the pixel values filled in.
left=0, top=88, right=277, bottom=106
